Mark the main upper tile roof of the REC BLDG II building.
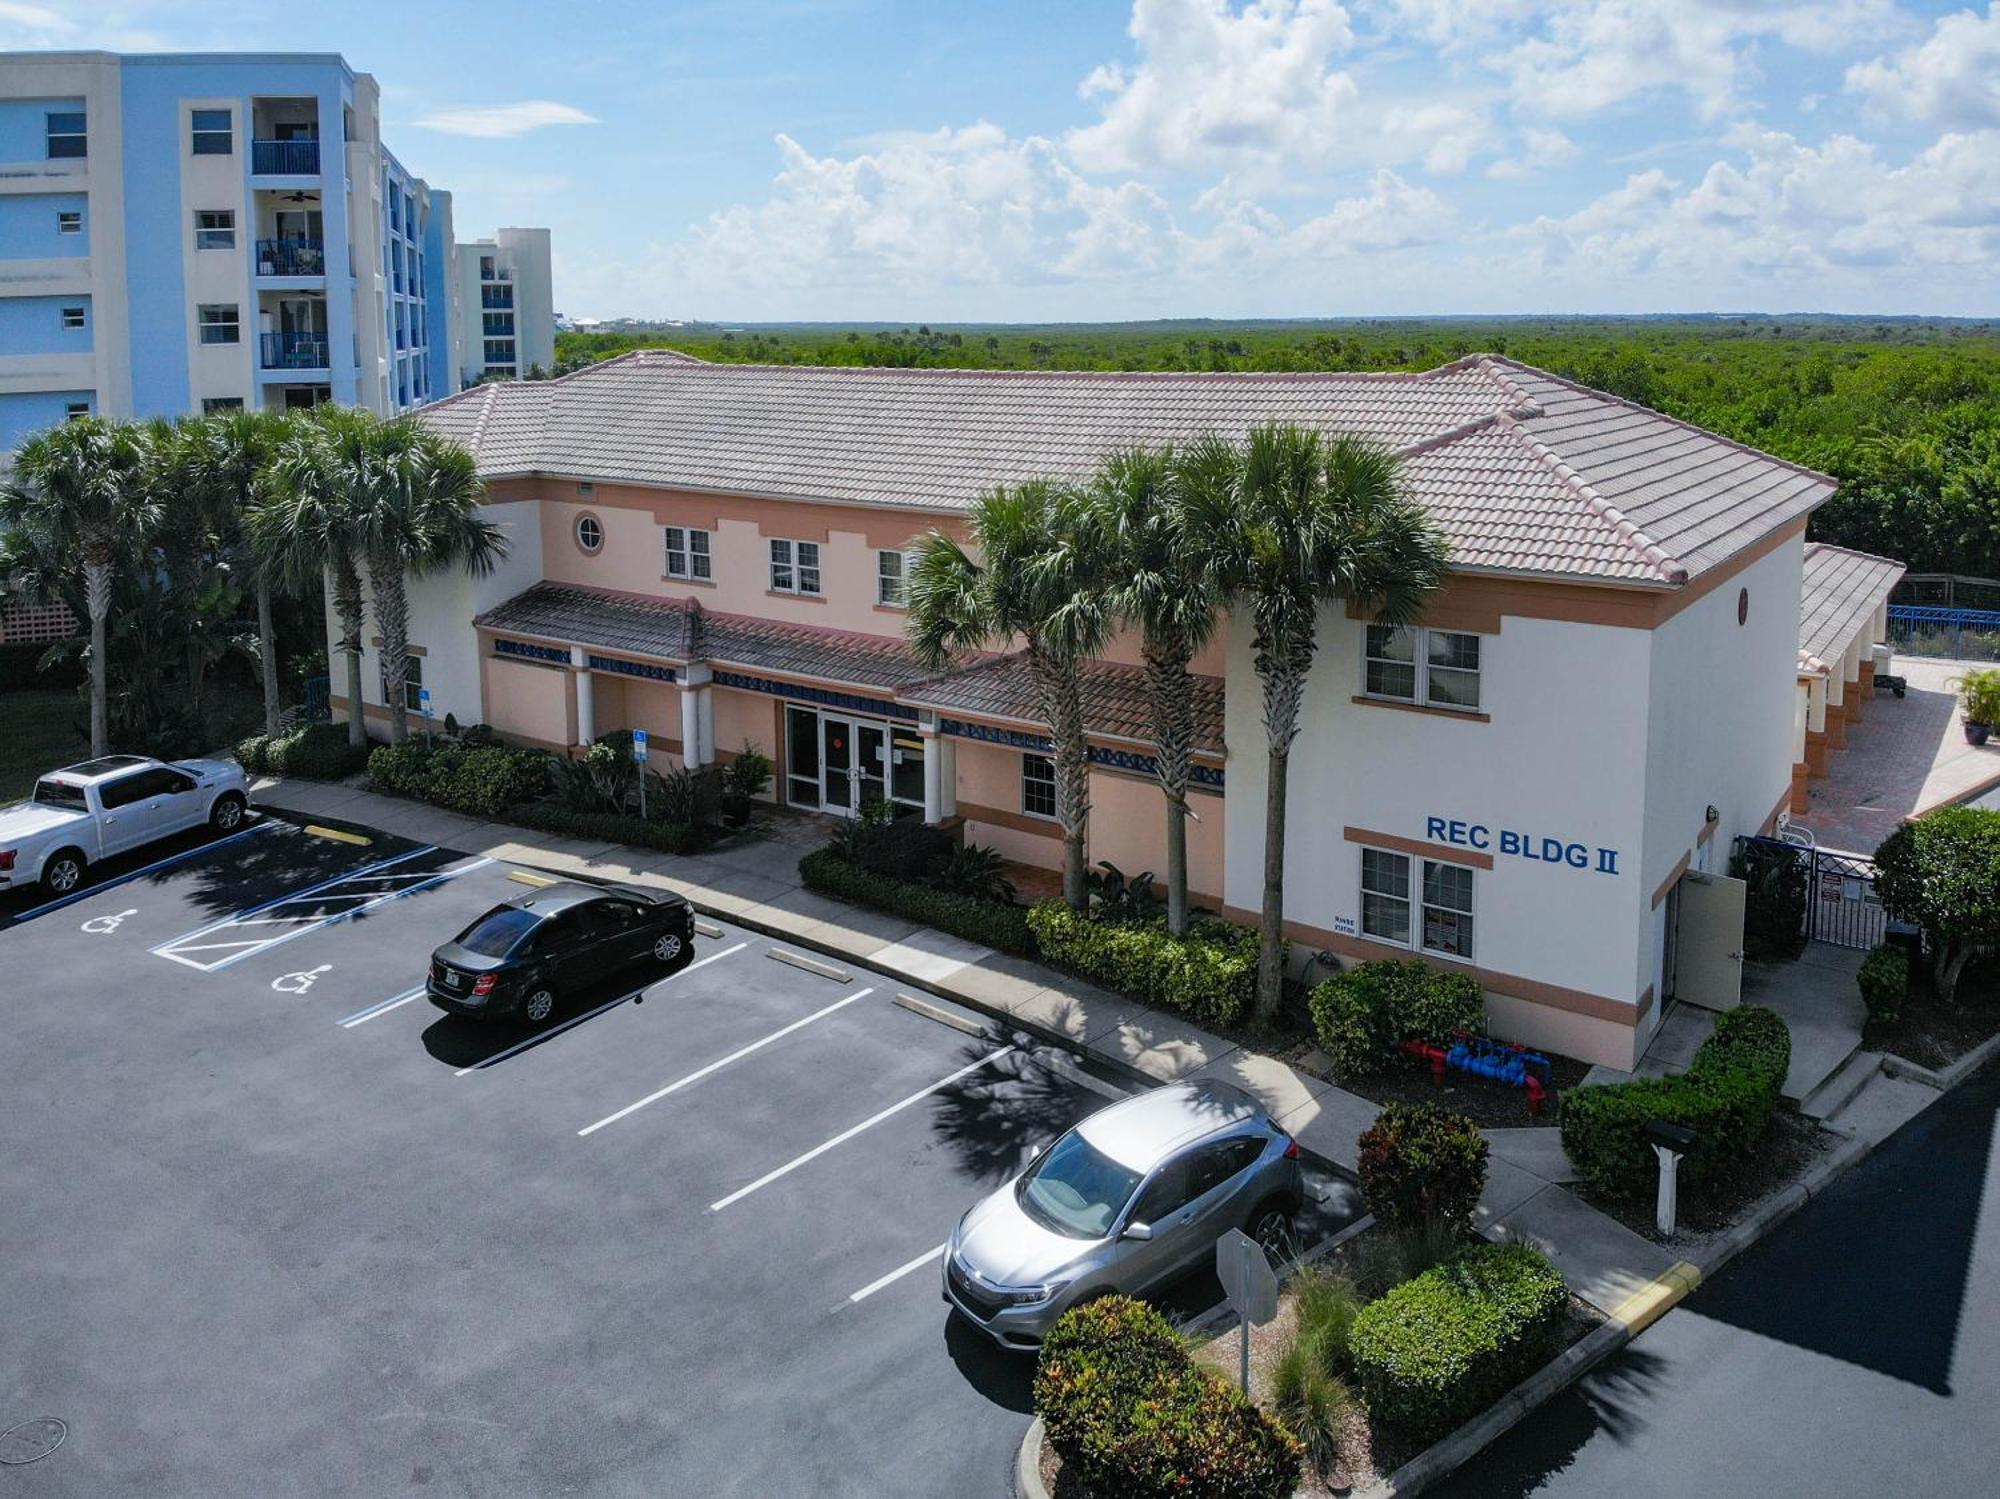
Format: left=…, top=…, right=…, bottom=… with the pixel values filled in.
left=422, top=350, right=1834, bottom=586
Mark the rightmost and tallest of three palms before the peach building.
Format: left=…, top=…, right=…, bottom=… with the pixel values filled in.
left=1190, top=426, right=1448, bottom=1025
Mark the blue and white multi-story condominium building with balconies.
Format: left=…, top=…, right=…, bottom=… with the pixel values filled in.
left=0, top=52, right=464, bottom=450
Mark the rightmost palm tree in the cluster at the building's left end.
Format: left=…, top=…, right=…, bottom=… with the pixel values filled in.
left=356, top=418, right=506, bottom=744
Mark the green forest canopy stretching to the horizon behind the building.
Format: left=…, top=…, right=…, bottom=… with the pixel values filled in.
left=556, top=316, right=2000, bottom=578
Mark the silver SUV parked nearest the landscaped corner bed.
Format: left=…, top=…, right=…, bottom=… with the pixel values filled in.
left=944, top=1081, right=1304, bottom=1349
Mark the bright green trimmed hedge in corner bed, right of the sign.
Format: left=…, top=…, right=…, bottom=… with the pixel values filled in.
left=1348, top=1243, right=1568, bottom=1443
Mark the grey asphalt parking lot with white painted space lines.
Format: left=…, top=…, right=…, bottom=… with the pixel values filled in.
left=0, top=817, right=1354, bottom=1499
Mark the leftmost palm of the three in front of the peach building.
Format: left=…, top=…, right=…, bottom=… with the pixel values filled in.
left=908, top=480, right=1116, bottom=911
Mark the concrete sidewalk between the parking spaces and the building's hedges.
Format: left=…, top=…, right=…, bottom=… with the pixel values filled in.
left=254, top=777, right=1672, bottom=1313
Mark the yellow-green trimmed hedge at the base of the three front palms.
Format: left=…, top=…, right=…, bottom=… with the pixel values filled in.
left=1028, top=899, right=1258, bottom=1027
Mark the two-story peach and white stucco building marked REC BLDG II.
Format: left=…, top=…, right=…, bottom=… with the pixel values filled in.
left=348, top=352, right=1904, bottom=1067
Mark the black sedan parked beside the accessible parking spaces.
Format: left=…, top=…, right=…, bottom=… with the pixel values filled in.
left=424, top=883, right=694, bottom=1023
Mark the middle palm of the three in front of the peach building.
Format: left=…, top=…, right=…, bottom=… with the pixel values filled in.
left=1092, top=438, right=1240, bottom=935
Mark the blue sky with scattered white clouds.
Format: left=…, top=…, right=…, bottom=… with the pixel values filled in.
left=15, top=0, right=2000, bottom=324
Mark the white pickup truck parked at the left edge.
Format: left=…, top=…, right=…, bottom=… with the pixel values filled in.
left=0, top=755, right=250, bottom=895
